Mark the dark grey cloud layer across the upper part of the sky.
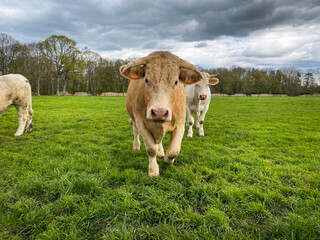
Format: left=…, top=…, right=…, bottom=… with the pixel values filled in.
left=0, top=0, right=320, bottom=51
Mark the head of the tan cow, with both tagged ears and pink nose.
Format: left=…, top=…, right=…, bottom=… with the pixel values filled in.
left=120, top=51, right=202, bottom=122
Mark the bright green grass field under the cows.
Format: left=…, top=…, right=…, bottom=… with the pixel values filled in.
left=0, top=96, right=320, bottom=240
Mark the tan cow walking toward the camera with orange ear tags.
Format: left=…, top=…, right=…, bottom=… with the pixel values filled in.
left=120, top=51, right=202, bottom=177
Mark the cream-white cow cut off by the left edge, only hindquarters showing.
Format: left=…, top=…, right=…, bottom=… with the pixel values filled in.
left=0, top=74, right=33, bottom=137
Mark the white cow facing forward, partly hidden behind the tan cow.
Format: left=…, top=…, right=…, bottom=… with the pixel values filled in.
left=185, top=72, right=219, bottom=138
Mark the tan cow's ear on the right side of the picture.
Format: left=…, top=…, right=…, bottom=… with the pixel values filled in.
left=179, top=59, right=202, bottom=85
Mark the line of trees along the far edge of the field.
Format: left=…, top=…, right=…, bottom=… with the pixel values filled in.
left=0, top=33, right=320, bottom=96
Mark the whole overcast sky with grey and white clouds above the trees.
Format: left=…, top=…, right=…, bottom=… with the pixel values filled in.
left=0, top=0, right=320, bottom=71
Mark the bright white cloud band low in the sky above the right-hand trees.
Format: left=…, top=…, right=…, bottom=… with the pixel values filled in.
left=102, top=22, right=320, bottom=70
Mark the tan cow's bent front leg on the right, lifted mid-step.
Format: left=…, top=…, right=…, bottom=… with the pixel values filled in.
left=163, top=124, right=184, bottom=164
